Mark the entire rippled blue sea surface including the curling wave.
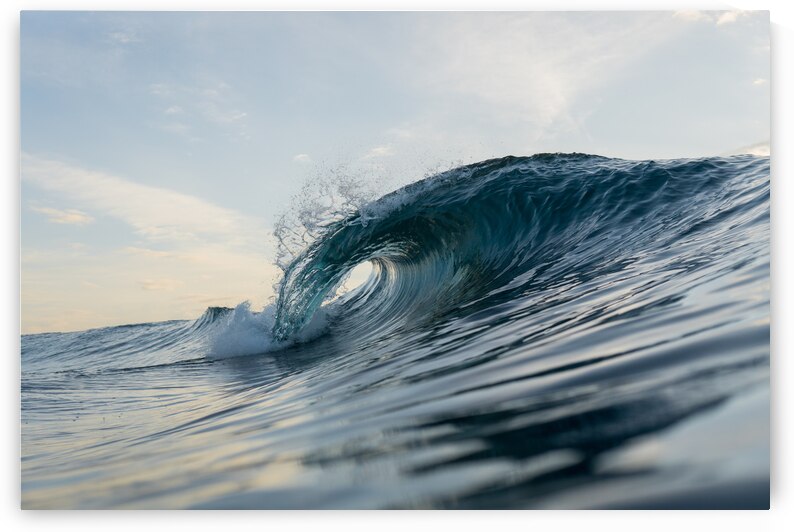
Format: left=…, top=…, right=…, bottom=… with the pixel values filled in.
left=21, top=154, right=770, bottom=508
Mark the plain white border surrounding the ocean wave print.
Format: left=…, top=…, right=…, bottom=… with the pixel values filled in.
left=0, top=0, right=794, bottom=532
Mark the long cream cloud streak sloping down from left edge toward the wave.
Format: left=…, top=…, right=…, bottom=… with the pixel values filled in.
left=22, top=154, right=264, bottom=247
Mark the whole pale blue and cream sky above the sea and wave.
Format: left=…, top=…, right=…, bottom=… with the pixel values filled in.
left=20, top=11, right=770, bottom=333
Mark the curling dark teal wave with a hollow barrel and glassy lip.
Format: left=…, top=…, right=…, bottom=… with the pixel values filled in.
left=243, top=154, right=768, bottom=351
